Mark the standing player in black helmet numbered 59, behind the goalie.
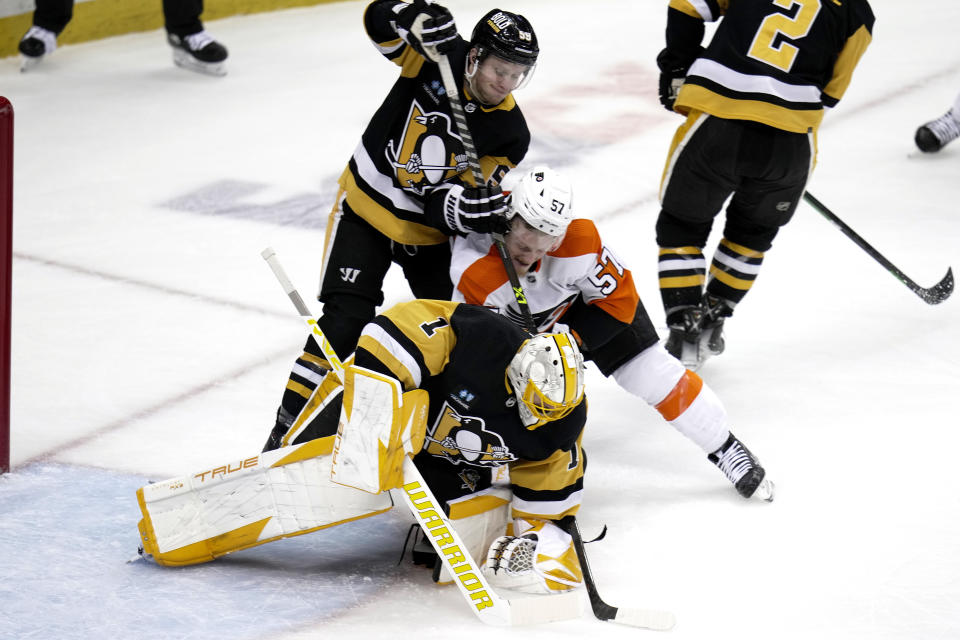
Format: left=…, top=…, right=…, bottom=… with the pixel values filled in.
left=277, top=0, right=539, bottom=444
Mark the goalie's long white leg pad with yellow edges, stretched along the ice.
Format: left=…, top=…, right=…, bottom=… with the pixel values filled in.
left=137, top=436, right=393, bottom=566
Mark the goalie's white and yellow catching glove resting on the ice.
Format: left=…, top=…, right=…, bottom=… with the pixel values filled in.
left=483, top=518, right=583, bottom=594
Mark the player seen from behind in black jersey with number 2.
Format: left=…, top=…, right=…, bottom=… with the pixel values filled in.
left=656, top=0, right=874, bottom=369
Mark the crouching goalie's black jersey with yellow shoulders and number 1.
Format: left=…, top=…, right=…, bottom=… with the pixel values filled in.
left=355, top=300, right=586, bottom=519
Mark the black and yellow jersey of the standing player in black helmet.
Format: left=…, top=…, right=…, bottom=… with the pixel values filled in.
left=340, top=0, right=530, bottom=245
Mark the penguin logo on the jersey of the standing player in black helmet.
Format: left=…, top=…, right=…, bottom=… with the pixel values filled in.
left=384, top=101, right=469, bottom=196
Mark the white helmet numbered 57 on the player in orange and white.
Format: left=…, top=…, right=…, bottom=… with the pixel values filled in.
left=507, top=166, right=573, bottom=237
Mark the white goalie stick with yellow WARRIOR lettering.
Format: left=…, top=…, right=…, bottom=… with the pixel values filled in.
left=261, top=247, right=580, bottom=626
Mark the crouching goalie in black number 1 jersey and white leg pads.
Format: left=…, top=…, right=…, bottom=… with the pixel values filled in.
left=137, top=300, right=587, bottom=592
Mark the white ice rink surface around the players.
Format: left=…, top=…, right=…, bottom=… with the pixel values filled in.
left=0, top=0, right=960, bottom=640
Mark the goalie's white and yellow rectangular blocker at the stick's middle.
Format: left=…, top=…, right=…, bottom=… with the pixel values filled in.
left=331, top=365, right=429, bottom=494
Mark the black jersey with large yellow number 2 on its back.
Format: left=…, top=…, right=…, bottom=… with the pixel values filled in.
left=667, top=0, right=874, bottom=133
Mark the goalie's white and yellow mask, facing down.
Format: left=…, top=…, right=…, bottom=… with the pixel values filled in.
left=507, top=333, right=584, bottom=429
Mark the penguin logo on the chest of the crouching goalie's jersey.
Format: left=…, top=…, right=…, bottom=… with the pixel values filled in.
left=426, top=403, right=517, bottom=467
